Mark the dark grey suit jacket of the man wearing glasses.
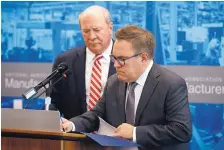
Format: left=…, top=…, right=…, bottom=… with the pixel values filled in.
left=71, top=63, right=192, bottom=150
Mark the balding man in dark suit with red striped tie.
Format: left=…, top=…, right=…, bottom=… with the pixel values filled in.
left=49, top=5, right=116, bottom=119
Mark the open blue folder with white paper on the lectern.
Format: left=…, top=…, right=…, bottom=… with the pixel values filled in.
left=83, top=117, right=139, bottom=150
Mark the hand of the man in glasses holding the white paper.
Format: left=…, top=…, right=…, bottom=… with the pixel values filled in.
left=114, top=123, right=134, bottom=140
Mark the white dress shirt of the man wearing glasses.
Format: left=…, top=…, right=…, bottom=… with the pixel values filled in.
left=125, top=60, right=153, bottom=142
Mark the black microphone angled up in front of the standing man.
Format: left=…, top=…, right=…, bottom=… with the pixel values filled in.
left=22, top=62, right=69, bottom=100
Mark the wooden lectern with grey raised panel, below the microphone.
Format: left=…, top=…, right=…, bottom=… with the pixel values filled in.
left=1, top=108, right=120, bottom=150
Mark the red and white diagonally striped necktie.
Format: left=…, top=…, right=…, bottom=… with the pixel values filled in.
left=88, top=55, right=103, bottom=110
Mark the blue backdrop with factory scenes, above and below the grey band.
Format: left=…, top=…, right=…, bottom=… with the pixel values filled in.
left=1, top=1, right=224, bottom=150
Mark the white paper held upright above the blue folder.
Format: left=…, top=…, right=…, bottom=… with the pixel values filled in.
left=97, top=117, right=138, bottom=150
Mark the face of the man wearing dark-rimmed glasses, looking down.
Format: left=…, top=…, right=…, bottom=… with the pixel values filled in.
left=113, top=40, right=143, bottom=82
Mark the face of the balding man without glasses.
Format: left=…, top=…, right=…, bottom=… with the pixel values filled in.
left=80, top=14, right=112, bottom=54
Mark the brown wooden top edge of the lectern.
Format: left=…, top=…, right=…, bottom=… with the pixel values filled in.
left=1, top=128, right=88, bottom=141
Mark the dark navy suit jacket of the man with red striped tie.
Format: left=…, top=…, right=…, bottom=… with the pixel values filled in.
left=49, top=46, right=116, bottom=119
